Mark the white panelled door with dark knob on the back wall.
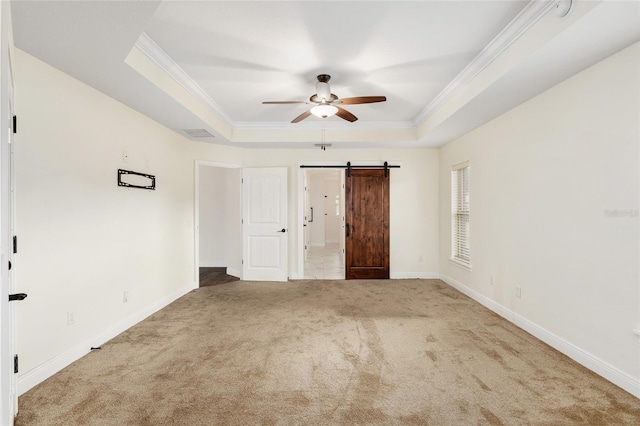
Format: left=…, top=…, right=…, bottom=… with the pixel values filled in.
left=242, top=167, right=289, bottom=281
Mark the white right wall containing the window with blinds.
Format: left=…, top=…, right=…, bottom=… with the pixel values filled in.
left=440, top=44, right=640, bottom=396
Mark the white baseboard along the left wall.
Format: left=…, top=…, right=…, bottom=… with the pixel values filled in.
left=16, top=283, right=196, bottom=395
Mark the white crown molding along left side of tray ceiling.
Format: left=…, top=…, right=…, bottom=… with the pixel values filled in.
left=135, top=32, right=235, bottom=127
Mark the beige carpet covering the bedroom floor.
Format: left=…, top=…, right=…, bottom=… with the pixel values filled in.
left=17, top=280, right=640, bottom=426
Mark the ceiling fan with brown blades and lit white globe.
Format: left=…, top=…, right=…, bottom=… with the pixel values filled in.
left=262, top=74, right=387, bottom=123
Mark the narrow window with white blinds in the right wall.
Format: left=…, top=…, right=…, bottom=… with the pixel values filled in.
left=451, top=162, right=471, bottom=267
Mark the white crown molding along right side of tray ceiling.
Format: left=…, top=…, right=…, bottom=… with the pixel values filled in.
left=414, top=0, right=558, bottom=125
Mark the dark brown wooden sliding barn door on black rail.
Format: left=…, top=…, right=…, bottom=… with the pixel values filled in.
left=345, top=169, right=389, bottom=280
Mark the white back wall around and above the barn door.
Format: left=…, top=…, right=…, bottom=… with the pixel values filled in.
left=244, top=148, right=439, bottom=278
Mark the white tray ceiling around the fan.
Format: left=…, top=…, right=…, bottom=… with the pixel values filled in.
left=12, top=0, right=640, bottom=149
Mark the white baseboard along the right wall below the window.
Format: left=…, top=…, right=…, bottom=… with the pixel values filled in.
left=440, top=274, right=640, bottom=398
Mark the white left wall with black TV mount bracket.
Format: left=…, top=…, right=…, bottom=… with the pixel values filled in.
left=14, top=51, right=241, bottom=392
